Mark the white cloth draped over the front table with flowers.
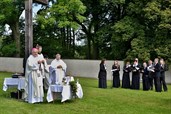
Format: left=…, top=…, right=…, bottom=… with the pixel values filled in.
left=46, top=83, right=83, bottom=102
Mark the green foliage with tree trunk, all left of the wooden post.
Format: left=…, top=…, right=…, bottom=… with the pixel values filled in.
left=0, top=0, right=24, bottom=57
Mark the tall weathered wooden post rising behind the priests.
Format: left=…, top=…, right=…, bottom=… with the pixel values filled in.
left=25, top=0, right=33, bottom=60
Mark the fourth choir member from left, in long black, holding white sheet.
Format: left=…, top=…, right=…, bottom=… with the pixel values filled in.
left=131, top=58, right=140, bottom=90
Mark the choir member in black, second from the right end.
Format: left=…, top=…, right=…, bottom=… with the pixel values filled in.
left=154, top=58, right=161, bottom=92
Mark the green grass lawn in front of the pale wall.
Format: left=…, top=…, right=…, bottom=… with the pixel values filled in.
left=0, top=72, right=171, bottom=114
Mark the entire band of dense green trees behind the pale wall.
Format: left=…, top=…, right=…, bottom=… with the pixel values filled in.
left=0, top=0, right=171, bottom=61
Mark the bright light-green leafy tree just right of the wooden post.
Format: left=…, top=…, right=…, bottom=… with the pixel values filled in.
left=36, top=0, right=85, bottom=58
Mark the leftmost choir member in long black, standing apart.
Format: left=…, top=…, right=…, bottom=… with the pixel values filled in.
left=98, top=59, right=107, bottom=88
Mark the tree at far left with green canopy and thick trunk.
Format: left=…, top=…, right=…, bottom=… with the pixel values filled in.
left=0, top=0, right=24, bottom=57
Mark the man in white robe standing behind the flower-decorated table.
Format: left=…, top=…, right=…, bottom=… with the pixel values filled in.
left=50, top=54, right=67, bottom=84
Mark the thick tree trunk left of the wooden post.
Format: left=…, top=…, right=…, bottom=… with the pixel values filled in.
left=9, top=21, right=20, bottom=57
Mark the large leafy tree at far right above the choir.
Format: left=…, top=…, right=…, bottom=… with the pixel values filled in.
left=113, top=0, right=171, bottom=61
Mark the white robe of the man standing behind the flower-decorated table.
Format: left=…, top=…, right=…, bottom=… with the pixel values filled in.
left=51, top=59, right=67, bottom=84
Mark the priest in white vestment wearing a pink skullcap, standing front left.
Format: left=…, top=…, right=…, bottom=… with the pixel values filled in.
left=24, top=48, right=44, bottom=103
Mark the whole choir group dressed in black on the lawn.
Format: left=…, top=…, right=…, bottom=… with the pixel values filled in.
left=98, top=58, right=168, bottom=92
